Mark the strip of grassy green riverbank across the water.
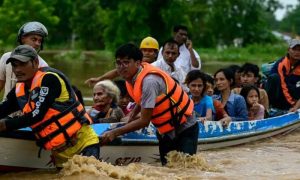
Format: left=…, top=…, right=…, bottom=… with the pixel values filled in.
left=36, top=43, right=287, bottom=64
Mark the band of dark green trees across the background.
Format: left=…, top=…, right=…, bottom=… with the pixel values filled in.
left=0, top=0, right=300, bottom=50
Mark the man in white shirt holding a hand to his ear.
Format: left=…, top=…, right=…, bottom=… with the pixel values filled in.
left=157, top=25, right=201, bottom=73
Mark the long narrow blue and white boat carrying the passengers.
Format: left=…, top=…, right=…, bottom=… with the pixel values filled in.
left=0, top=111, right=300, bottom=171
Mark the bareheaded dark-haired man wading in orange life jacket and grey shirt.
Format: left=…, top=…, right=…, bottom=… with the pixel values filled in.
left=101, top=44, right=199, bottom=165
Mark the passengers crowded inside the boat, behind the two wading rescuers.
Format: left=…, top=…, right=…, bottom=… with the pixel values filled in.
left=85, top=25, right=300, bottom=125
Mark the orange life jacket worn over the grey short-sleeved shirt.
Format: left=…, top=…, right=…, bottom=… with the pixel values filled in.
left=126, top=63, right=194, bottom=134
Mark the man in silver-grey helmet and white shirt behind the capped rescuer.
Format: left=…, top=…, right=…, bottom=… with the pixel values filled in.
left=0, top=21, right=48, bottom=99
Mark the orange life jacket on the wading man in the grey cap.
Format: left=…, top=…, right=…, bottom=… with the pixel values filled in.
left=16, top=67, right=92, bottom=150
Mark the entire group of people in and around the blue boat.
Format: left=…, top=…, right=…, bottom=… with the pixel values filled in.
left=0, top=22, right=300, bottom=167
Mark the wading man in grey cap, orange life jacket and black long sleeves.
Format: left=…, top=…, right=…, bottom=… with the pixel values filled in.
left=0, top=45, right=99, bottom=167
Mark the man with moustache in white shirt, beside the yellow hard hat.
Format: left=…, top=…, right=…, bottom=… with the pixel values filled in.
left=151, top=40, right=189, bottom=92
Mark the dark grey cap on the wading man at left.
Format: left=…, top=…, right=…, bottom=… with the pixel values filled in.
left=6, top=45, right=38, bottom=64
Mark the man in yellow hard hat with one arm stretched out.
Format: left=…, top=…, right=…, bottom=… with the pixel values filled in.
left=85, top=36, right=159, bottom=86
